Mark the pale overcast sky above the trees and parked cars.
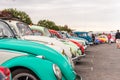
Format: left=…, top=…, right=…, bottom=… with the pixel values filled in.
left=0, top=0, right=120, bottom=31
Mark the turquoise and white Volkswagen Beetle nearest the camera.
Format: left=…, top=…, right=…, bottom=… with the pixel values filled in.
left=0, top=20, right=81, bottom=80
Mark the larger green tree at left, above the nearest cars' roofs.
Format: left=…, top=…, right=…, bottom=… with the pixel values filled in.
left=3, top=8, right=32, bottom=24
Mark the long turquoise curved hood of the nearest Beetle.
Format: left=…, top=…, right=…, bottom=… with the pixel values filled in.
left=0, top=39, right=75, bottom=80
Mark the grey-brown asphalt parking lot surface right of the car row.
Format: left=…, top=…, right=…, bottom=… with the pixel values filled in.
left=75, top=43, right=120, bottom=80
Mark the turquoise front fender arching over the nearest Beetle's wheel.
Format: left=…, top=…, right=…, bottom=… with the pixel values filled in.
left=2, top=56, right=57, bottom=80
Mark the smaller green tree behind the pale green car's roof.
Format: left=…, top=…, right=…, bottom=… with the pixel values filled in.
left=37, top=20, right=59, bottom=30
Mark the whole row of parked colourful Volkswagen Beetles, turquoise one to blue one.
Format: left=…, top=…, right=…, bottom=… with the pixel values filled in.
left=0, top=14, right=93, bottom=80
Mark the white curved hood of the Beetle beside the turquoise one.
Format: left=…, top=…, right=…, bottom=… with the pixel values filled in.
left=22, top=35, right=72, bottom=57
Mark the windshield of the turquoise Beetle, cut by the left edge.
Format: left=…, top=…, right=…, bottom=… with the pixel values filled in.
left=0, top=21, right=13, bottom=38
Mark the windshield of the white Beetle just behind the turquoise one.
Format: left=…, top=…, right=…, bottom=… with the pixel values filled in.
left=17, top=23, right=33, bottom=36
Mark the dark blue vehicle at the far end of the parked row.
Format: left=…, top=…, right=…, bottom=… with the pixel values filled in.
left=74, top=31, right=93, bottom=44
